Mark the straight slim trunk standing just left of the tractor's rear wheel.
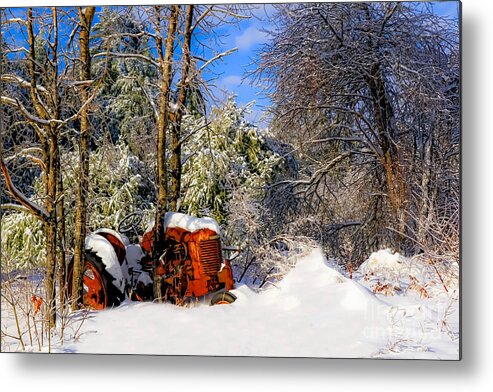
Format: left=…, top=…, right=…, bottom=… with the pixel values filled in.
left=72, top=7, right=95, bottom=310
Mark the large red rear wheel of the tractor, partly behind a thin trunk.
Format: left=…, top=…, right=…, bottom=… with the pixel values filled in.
left=67, top=251, right=124, bottom=310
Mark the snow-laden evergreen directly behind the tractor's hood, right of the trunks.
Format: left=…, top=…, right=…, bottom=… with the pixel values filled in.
left=182, top=98, right=281, bottom=223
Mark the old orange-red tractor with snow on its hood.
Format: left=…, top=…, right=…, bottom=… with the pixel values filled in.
left=67, top=212, right=239, bottom=310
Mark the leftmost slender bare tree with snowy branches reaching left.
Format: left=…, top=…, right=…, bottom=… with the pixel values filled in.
left=1, top=8, right=64, bottom=327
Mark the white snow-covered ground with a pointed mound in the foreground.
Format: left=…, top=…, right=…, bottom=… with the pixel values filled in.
left=2, top=249, right=459, bottom=359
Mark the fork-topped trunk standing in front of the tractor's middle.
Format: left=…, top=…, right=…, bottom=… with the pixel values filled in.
left=153, top=5, right=180, bottom=302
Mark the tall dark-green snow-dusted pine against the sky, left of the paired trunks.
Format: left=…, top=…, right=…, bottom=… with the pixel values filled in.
left=94, top=7, right=158, bottom=161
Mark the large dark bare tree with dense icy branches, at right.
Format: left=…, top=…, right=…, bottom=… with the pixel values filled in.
left=255, top=2, right=460, bottom=262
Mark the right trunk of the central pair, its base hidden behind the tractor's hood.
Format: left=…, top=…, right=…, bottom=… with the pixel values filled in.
left=170, top=4, right=194, bottom=211
